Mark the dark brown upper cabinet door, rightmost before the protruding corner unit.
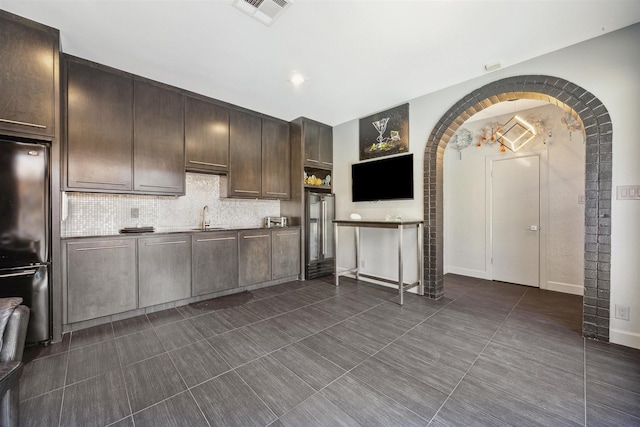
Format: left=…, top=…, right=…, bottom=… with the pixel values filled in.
left=262, top=119, right=291, bottom=199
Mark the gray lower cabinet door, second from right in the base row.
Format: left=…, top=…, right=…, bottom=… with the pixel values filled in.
left=238, top=230, right=271, bottom=286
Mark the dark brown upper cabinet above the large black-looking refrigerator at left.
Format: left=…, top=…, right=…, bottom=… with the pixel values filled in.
left=0, top=10, right=59, bottom=139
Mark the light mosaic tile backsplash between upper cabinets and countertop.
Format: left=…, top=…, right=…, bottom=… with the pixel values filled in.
left=61, top=173, right=280, bottom=237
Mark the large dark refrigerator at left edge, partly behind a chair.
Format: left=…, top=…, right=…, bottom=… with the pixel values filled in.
left=0, top=138, right=51, bottom=342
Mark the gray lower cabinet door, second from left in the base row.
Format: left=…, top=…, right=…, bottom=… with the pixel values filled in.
left=138, top=234, right=191, bottom=307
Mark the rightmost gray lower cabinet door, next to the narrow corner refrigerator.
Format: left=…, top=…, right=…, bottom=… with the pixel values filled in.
left=271, top=228, right=300, bottom=279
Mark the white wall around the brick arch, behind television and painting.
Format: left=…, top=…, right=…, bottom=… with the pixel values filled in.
left=334, top=24, right=640, bottom=348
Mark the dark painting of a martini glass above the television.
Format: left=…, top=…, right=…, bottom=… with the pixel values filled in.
left=360, top=104, right=409, bottom=160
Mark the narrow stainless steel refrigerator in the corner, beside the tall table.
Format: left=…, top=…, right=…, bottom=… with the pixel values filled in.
left=305, top=191, right=335, bottom=279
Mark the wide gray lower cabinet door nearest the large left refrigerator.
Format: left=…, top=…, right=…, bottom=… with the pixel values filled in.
left=64, top=239, right=138, bottom=323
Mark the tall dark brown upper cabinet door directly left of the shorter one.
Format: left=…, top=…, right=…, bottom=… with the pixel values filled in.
left=133, top=81, right=185, bottom=195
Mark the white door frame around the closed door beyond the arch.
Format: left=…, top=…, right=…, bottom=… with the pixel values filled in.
left=485, top=147, right=549, bottom=289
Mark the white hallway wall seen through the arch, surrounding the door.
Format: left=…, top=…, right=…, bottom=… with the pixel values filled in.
left=444, top=104, right=585, bottom=295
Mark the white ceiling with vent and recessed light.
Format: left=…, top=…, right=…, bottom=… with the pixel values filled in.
left=0, top=0, right=640, bottom=125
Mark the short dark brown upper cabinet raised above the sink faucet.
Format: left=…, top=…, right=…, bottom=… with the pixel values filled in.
left=184, top=97, right=229, bottom=173
